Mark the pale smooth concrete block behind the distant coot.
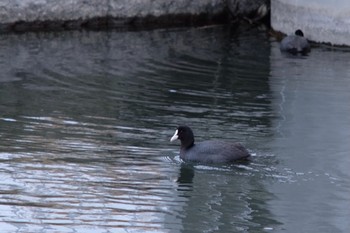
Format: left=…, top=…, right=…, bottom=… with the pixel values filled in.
left=271, top=0, right=350, bottom=46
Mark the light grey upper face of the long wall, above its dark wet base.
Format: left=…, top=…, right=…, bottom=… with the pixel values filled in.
left=0, top=0, right=225, bottom=23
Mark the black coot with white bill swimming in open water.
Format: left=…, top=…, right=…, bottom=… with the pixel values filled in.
left=170, top=126, right=250, bottom=163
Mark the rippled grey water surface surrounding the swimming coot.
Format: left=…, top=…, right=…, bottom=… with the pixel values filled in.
left=0, top=26, right=350, bottom=233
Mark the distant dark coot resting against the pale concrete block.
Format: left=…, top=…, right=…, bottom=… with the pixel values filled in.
left=280, top=29, right=310, bottom=55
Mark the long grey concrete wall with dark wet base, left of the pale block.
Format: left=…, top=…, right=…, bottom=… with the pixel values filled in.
left=0, top=0, right=269, bottom=31
